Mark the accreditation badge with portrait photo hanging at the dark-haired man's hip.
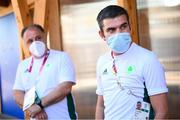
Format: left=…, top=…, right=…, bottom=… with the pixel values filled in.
left=135, top=101, right=150, bottom=120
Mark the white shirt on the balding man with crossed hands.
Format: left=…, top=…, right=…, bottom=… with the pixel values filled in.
left=13, top=50, right=76, bottom=119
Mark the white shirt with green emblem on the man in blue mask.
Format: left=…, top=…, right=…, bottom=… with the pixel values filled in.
left=96, top=43, right=168, bottom=120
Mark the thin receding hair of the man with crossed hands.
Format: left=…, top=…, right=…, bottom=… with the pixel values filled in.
left=21, top=24, right=45, bottom=38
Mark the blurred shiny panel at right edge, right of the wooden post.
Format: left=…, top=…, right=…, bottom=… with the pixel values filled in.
left=137, top=0, right=180, bottom=118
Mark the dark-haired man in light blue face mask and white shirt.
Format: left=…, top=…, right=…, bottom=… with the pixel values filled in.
left=95, top=5, right=168, bottom=120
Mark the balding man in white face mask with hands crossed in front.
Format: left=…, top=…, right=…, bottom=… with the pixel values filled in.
left=13, top=24, right=77, bottom=120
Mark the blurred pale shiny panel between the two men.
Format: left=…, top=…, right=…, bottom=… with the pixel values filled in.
left=61, top=0, right=116, bottom=119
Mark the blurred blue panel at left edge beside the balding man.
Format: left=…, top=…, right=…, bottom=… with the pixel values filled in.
left=0, top=13, right=23, bottom=118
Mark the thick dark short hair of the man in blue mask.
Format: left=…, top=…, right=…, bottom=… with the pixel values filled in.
left=96, top=5, right=129, bottom=30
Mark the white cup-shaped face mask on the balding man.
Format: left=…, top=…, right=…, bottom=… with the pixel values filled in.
left=29, top=41, right=46, bottom=57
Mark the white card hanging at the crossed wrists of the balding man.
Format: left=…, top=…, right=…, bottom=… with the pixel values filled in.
left=23, top=86, right=36, bottom=111
